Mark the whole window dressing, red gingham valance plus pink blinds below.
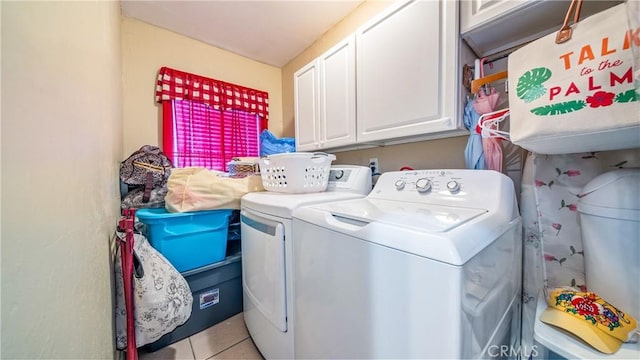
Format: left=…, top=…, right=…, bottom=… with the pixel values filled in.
left=156, top=67, right=269, bottom=171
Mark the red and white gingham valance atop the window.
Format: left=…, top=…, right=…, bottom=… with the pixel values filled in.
left=156, top=66, right=269, bottom=121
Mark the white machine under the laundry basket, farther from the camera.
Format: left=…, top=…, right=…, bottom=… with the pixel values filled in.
left=240, top=165, right=371, bottom=359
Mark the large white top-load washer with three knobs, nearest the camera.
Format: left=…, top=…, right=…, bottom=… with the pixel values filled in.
left=293, top=170, right=522, bottom=359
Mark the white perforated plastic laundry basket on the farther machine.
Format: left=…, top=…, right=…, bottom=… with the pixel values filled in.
left=260, top=152, right=336, bottom=193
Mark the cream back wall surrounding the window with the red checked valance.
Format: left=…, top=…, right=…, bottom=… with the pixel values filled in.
left=122, top=17, right=282, bottom=154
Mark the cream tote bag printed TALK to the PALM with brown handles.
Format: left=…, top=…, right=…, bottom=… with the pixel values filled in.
left=508, top=0, right=640, bottom=154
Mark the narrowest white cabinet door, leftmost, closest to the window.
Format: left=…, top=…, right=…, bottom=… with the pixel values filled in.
left=293, top=60, right=320, bottom=151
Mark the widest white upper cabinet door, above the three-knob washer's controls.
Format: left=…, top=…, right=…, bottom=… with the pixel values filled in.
left=356, top=0, right=458, bottom=143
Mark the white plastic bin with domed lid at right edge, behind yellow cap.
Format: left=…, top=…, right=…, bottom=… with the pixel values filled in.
left=578, top=169, right=640, bottom=319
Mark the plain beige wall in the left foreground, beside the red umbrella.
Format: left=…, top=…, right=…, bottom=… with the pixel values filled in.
left=0, top=1, right=122, bottom=359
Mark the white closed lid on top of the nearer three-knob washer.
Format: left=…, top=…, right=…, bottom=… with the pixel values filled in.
left=316, top=198, right=487, bottom=233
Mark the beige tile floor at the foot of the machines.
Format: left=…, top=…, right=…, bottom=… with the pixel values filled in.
left=138, top=313, right=264, bottom=360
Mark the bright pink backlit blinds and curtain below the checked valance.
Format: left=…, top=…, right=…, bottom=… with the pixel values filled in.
left=168, top=100, right=261, bottom=171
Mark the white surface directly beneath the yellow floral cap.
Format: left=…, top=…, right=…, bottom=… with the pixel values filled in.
left=534, top=291, right=640, bottom=360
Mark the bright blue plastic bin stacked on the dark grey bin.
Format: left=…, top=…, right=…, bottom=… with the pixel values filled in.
left=136, top=208, right=231, bottom=272
